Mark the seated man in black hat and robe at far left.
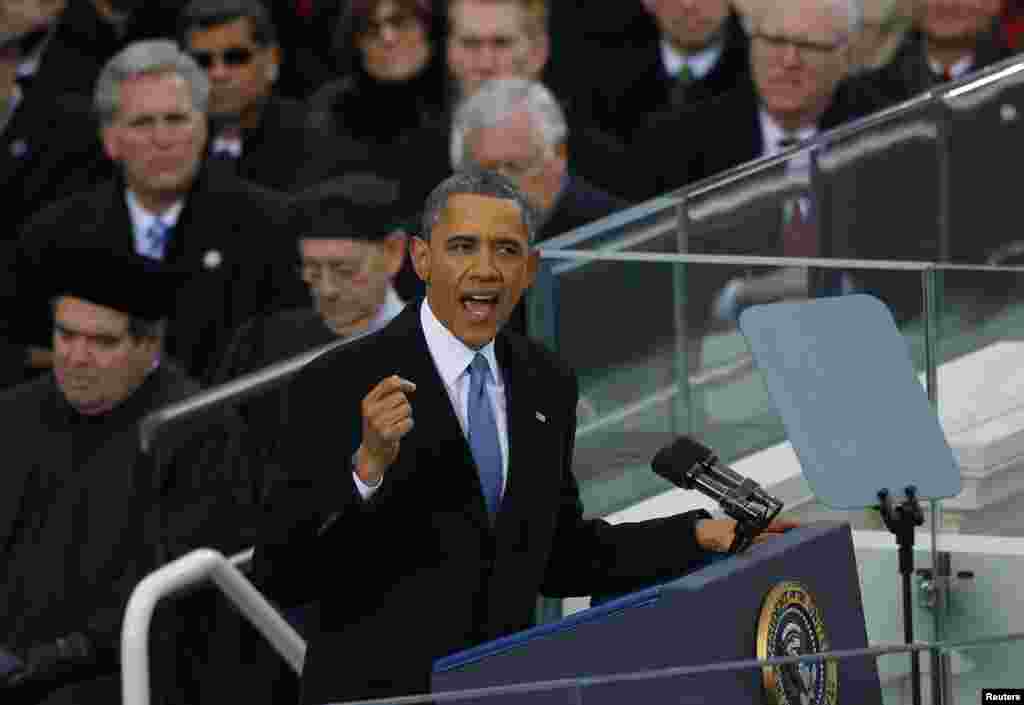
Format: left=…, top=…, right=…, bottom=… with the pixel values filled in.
left=0, top=249, right=252, bottom=705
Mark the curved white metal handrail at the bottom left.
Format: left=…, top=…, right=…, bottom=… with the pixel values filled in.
left=121, top=548, right=306, bottom=705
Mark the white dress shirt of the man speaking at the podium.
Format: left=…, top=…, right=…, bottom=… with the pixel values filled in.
left=352, top=298, right=509, bottom=499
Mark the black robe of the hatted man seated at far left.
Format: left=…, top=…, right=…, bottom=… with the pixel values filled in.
left=0, top=364, right=254, bottom=705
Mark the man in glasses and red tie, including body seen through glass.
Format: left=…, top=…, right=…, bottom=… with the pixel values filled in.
left=634, top=0, right=885, bottom=352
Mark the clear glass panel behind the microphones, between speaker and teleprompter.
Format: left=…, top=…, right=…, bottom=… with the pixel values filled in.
left=546, top=251, right=925, bottom=518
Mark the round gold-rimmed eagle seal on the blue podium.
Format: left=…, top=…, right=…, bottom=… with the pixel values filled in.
left=758, top=581, right=839, bottom=705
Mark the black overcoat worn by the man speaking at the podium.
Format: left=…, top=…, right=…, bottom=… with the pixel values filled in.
left=254, top=305, right=706, bottom=703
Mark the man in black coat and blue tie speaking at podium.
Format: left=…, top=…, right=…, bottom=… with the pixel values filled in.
left=255, top=172, right=785, bottom=704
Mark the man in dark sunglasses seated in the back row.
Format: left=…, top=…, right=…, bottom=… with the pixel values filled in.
left=178, top=0, right=369, bottom=191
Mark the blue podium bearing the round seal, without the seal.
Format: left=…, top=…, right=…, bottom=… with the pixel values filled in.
left=433, top=523, right=882, bottom=705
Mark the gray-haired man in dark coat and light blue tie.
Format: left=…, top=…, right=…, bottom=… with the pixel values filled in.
left=8, top=41, right=303, bottom=379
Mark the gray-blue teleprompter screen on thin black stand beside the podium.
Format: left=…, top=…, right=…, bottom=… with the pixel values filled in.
left=739, top=294, right=962, bottom=705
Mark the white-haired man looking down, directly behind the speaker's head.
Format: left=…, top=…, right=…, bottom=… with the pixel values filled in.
left=451, top=78, right=628, bottom=242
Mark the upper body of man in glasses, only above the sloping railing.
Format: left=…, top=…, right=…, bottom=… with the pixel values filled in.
left=637, top=0, right=883, bottom=197
